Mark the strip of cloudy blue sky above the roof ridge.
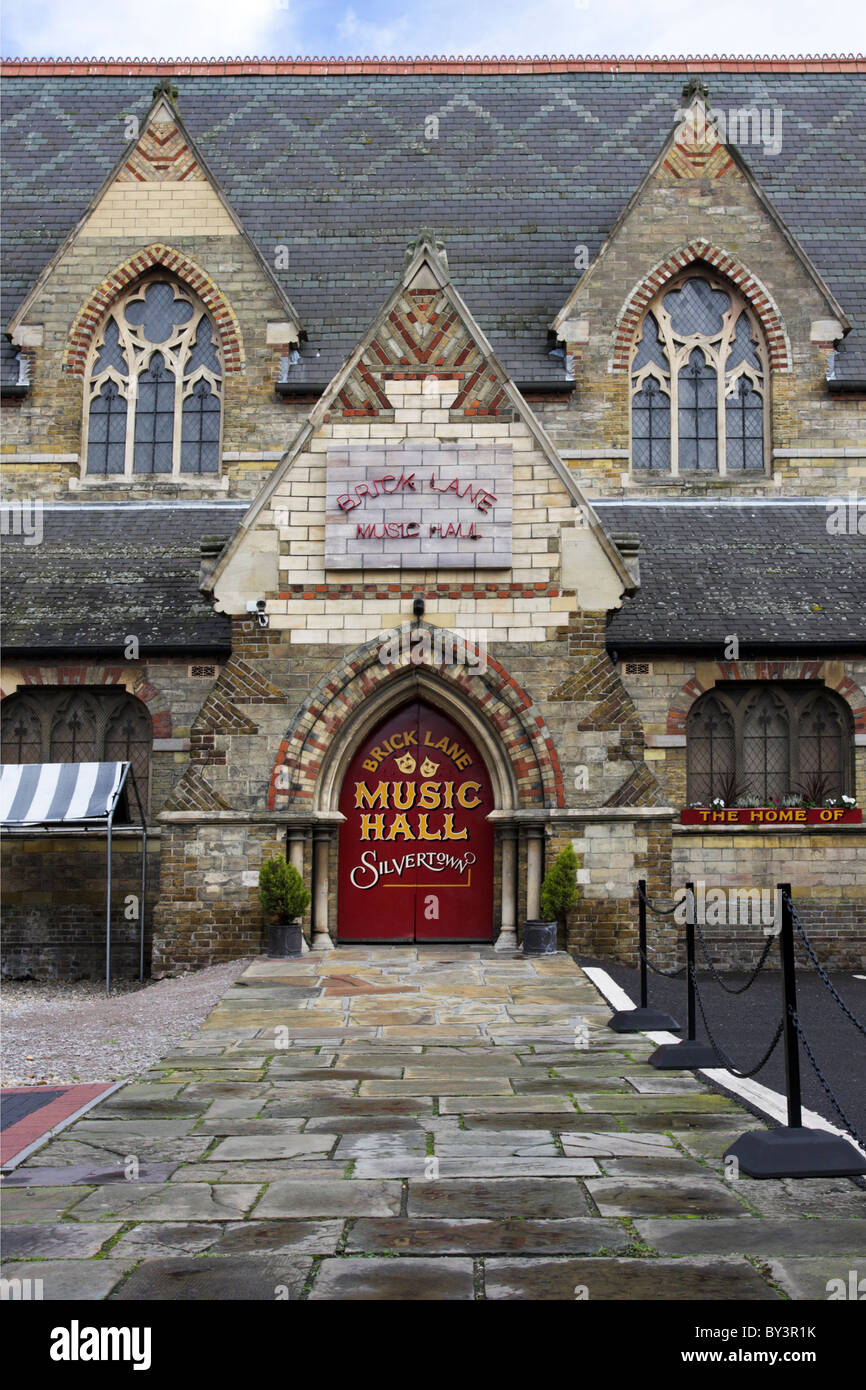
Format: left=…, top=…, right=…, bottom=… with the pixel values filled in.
left=0, top=0, right=866, bottom=58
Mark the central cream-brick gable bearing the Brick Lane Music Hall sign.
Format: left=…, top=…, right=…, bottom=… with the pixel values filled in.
left=210, top=235, right=634, bottom=613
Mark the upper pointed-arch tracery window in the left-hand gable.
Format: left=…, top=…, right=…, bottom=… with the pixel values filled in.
left=83, top=272, right=222, bottom=478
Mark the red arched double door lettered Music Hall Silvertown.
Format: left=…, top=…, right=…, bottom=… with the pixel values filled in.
left=338, top=701, right=493, bottom=941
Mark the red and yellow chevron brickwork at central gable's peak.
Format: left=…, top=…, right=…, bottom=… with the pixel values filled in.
left=325, top=279, right=514, bottom=421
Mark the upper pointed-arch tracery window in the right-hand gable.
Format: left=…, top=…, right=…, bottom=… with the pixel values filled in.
left=631, top=267, right=769, bottom=478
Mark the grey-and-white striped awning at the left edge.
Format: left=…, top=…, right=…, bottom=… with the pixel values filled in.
left=0, top=763, right=129, bottom=826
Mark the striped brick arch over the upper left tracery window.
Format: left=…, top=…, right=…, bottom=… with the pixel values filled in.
left=63, top=242, right=243, bottom=377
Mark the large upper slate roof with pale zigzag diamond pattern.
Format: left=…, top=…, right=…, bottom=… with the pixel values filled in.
left=3, top=64, right=866, bottom=386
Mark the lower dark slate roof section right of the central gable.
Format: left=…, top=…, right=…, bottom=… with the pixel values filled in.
left=592, top=499, right=866, bottom=653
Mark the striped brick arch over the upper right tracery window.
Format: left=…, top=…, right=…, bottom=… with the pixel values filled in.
left=610, top=238, right=791, bottom=371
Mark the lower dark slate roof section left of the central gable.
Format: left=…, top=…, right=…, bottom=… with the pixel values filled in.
left=0, top=502, right=249, bottom=656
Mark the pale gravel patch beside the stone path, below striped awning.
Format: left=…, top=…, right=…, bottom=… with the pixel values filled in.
left=3, top=958, right=252, bottom=1086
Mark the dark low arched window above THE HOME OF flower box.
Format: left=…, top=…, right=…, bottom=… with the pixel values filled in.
left=685, top=681, right=853, bottom=806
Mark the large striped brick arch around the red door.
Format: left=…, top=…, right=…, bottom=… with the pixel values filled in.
left=268, top=626, right=564, bottom=810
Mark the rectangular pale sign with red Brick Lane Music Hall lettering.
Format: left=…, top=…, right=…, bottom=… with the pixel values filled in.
left=325, top=445, right=513, bottom=570
